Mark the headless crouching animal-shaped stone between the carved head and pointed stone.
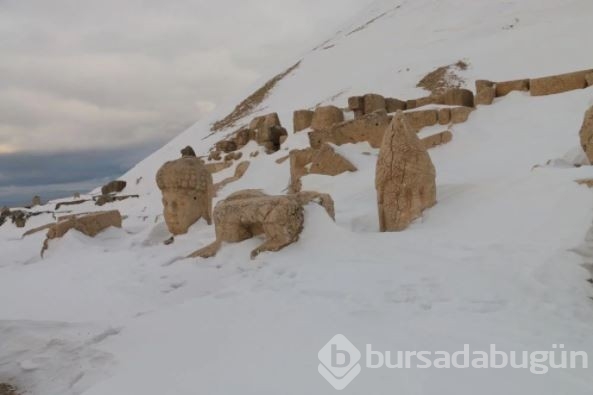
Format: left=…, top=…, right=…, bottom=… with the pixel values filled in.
left=190, top=189, right=334, bottom=259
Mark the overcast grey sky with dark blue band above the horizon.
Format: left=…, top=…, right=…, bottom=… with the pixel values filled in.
left=0, top=0, right=371, bottom=206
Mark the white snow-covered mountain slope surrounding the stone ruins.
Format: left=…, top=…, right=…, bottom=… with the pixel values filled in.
left=0, top=0, right=593, bottom=395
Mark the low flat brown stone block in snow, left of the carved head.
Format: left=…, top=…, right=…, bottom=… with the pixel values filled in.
left=41, top=210, right=122, bottom=257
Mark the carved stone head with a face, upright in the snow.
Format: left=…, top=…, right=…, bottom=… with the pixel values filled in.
left=156, top=156, right=214, bottom=235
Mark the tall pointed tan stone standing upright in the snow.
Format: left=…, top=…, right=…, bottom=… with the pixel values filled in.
left=375, top=112, right=436, bottom=232
